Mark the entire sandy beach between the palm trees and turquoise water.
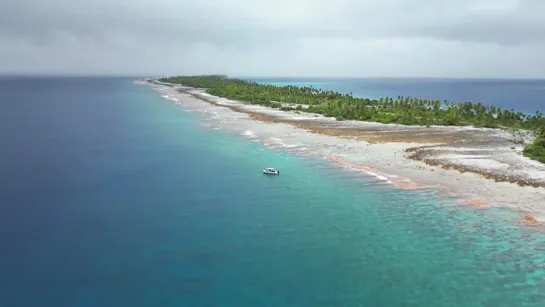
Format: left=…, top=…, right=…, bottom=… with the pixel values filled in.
left=142, top=80, right=545, bottom=225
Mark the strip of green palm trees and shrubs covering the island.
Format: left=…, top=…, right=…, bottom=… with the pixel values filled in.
left=159, top=75, right=545, bottom=163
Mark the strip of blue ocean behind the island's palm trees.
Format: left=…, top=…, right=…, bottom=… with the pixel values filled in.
left=252, top=77, right=545, bottom=115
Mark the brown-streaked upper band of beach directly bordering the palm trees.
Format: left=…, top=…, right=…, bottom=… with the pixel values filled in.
left=173, top=82, right=545, bottom=187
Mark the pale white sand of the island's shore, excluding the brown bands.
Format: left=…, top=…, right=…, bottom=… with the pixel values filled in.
left=143, top=81, right=545, bottom=220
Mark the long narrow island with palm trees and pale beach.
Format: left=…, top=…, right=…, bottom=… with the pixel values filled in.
left=143, top=75, right=545, bottom=224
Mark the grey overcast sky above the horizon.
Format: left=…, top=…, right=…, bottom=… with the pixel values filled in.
left=0, top=0, right=545, bottom=78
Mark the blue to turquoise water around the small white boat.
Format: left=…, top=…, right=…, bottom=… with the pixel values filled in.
left=0, top=78, right=545, bottom=307
